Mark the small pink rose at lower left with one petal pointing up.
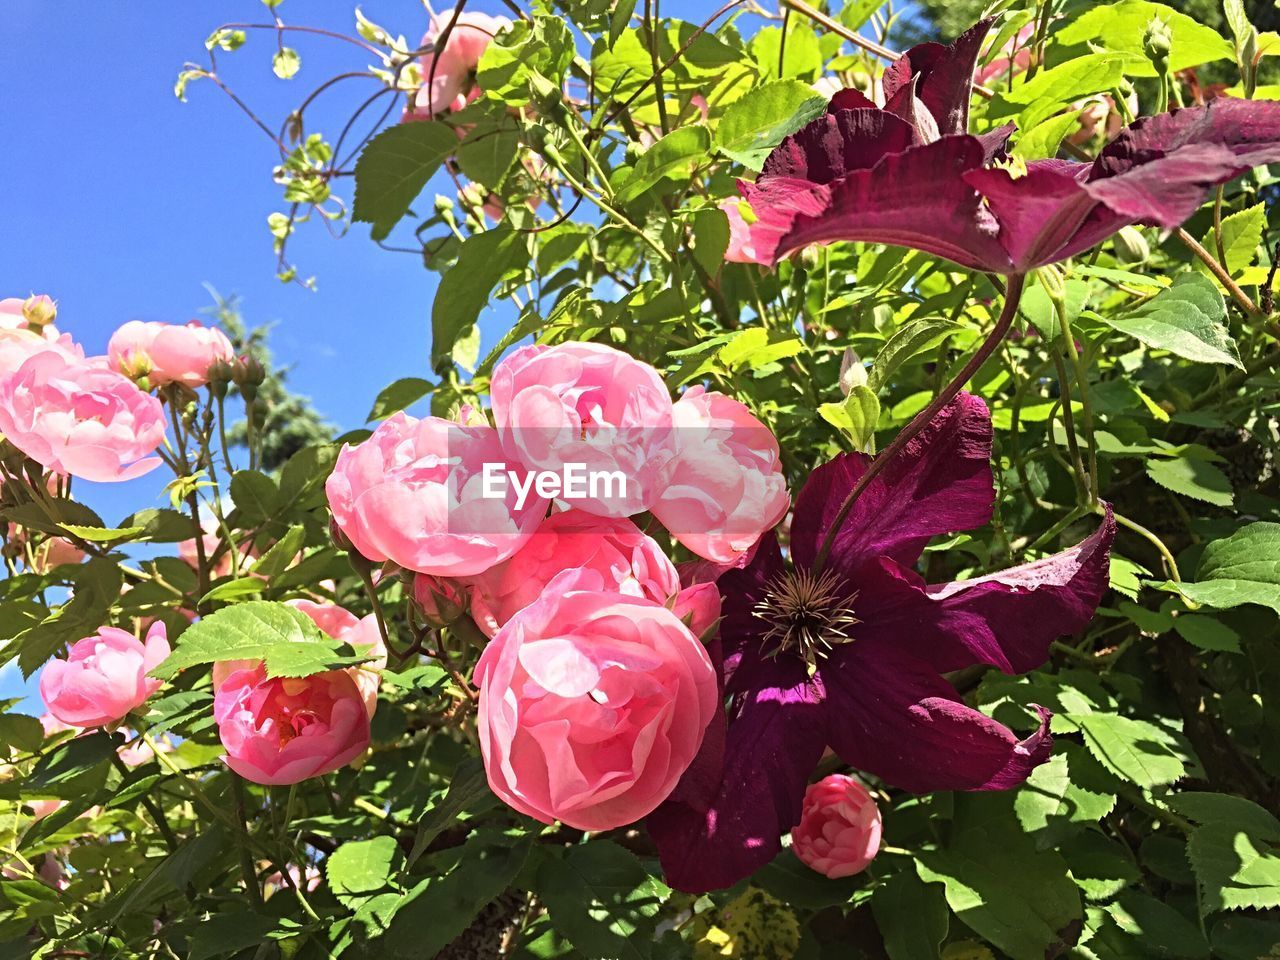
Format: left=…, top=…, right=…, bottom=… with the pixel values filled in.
left=40, top=622, right=169, bottom=727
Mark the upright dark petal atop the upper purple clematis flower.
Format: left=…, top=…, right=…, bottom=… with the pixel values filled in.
left=881, top=18, right=992, bottom=134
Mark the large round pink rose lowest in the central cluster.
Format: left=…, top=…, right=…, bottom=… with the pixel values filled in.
left=475, top=589, right=717, bottom=831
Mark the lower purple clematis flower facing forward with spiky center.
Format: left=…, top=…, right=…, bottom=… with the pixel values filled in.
left=648, top=393, right=1115, bottom=892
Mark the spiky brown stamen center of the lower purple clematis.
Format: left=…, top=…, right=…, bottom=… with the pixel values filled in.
left=753, top=570, right=858, bottom=669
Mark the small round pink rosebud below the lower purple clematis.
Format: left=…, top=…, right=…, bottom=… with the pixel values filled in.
left=791, top=773, right=881, bottom=879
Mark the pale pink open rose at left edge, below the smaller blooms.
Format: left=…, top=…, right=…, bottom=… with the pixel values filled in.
left=0, top=349, right=164, bottom=481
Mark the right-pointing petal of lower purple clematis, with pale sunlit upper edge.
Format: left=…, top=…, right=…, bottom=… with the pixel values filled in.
left=858, top=507, right=1116, bottom=673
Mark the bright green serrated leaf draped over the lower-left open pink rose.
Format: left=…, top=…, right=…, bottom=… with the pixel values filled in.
left=151, top=600, right=369, bottom=680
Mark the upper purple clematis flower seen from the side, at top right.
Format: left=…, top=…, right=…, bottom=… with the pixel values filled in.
left=739, top=20, right=1280, bottom=274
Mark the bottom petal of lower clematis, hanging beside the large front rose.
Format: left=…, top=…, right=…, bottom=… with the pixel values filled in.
left=646, top=662, right=827, bottom=892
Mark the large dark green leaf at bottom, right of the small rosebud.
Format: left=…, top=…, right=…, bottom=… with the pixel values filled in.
left=916, top=795, right=1082, bottom=960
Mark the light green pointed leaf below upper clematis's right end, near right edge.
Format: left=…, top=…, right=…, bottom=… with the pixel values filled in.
left=1101, top=273, right=1243, bottom=369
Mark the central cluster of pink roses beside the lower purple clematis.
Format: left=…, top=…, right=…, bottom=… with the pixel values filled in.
left=326, top=343, right=790, bottom=829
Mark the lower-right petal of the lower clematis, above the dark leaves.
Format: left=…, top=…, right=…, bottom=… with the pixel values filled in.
left=819, top=643, right=1052, bottom=794
